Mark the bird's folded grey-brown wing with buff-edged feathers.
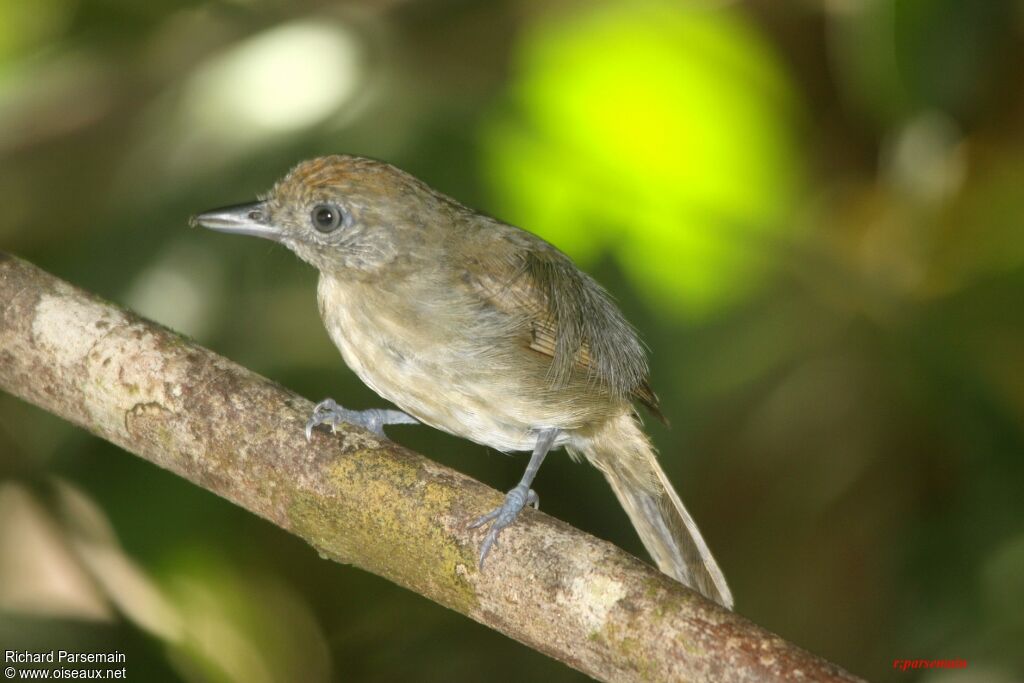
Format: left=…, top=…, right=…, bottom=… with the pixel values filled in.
left=465, top=228, right=665, bottom=421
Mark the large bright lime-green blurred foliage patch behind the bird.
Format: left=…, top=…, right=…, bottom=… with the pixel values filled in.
left=483, top=2, right=802, bottom=316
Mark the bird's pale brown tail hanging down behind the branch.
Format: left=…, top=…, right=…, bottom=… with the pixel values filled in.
left=569, top=415, right=732, bottom=609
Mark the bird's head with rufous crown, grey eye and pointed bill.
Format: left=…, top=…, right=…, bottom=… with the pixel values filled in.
left=191, top=155, right=456, bottom=278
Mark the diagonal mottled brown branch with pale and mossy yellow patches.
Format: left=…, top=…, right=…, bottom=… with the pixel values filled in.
left=0, top=252, right=858, bottom=681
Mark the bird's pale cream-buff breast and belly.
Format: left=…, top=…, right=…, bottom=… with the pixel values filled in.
left=317, top=276, right=573, bottom=451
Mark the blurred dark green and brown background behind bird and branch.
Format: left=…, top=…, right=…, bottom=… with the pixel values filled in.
left=0, top=0, right=1024, bottom=682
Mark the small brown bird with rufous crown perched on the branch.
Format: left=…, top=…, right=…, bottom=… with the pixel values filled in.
left=190, top=155, right=733, bottom=609
